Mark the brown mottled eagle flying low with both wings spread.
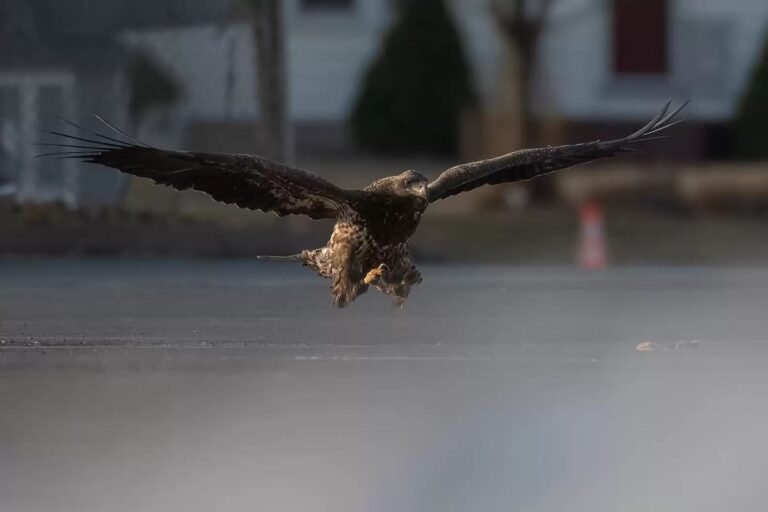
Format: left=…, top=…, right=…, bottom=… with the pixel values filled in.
left=41, top=102, right=685, bottom=307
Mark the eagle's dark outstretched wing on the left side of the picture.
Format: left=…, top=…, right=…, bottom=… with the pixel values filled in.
left=40, top=122, right=362, bottom=219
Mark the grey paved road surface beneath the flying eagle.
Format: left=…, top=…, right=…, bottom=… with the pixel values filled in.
left=0, top=260, right=768, bottom=512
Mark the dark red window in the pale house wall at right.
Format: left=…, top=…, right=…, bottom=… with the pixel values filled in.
left=613, top=0, right=669, bottom=74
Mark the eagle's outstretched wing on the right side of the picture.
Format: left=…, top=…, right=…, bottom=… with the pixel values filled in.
left=429, top=102, right=688, bottom=203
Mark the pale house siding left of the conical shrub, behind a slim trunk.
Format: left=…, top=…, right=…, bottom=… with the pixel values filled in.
left=123, top=0, right=390, bottom=123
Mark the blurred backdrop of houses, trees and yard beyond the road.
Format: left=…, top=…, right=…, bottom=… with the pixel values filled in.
left=0, top=0, right=768, bottom=264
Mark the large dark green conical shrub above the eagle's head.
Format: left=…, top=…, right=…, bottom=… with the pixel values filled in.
left=351, top=0, right=474, bottom=154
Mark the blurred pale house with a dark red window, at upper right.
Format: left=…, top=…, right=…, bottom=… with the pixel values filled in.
left=536, top=0, right=768, bottom=158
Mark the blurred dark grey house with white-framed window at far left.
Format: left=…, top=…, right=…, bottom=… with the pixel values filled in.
left=0, top=0, right=236, bottom=206
